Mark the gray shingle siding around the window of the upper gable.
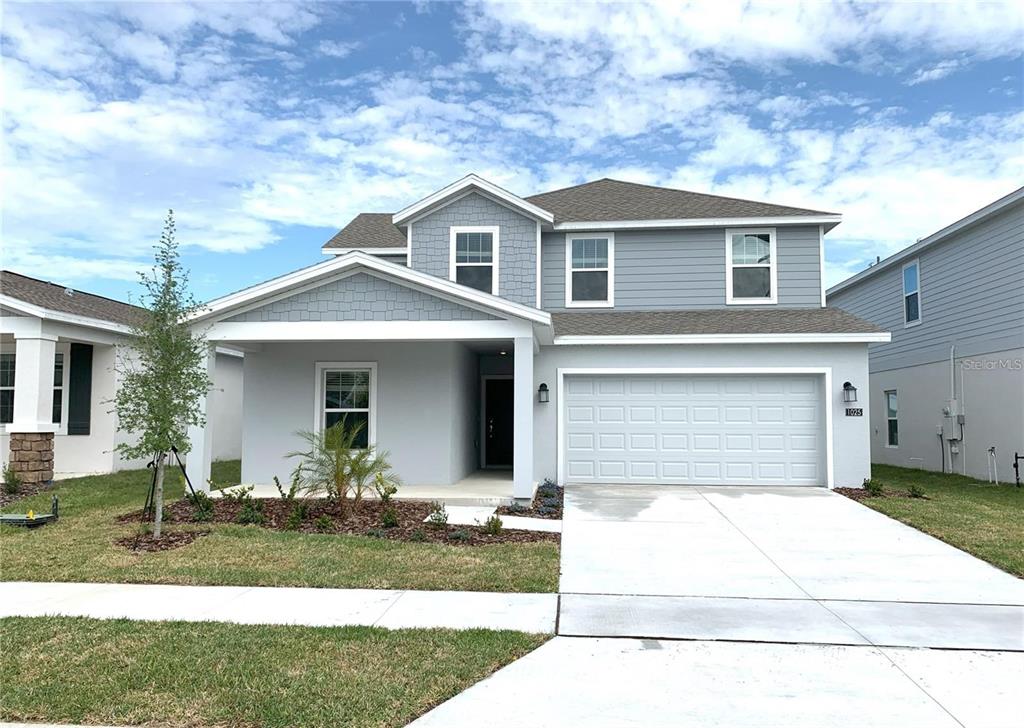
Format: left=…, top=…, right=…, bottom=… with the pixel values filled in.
left=412, top=192, right=537, bottom=306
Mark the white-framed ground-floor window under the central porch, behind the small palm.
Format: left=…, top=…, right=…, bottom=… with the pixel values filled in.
left=316, top=363, right=377, bottom=447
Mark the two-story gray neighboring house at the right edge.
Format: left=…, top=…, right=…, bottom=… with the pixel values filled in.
left=828, top=187, right=1024, bottom=479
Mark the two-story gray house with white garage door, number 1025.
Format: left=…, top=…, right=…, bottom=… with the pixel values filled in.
left=189, top=175, right=889, bottom=498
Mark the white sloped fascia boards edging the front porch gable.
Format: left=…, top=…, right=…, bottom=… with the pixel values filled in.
left=193, top=252, right=551, bottom=326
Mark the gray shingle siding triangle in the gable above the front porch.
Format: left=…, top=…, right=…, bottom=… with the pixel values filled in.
left=226, top=273, right=495, bottom=322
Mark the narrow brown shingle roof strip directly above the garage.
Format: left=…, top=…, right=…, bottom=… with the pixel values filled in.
left=551, top=308, right=885, bottom=336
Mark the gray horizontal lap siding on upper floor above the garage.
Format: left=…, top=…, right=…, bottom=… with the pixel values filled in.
left=541, top=225, right=821, bottom=310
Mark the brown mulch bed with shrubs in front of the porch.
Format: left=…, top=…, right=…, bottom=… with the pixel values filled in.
left=118, top=498, right=561, bottom=546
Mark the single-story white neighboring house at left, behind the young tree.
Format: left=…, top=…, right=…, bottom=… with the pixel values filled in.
left=0, top=270, right=242, bottom=481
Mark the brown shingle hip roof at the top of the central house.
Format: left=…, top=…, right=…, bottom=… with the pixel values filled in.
left=526, top=178, right=835, bottom=223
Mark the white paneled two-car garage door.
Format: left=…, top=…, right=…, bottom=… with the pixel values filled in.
left=562, top=375, right=825, bottom=485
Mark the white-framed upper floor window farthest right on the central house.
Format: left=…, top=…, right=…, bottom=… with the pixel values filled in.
left=725, top=228, right=778, bottom=304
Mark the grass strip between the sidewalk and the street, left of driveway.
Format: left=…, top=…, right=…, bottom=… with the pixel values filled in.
left=0, top=617, right=547, bottom=728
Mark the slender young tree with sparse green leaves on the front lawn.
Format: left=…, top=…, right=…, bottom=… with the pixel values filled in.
left=114, top=210, right=212, bottom=539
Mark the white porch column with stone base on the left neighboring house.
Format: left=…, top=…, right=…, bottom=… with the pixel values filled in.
left=7, top=333, right=57, bottom=483
